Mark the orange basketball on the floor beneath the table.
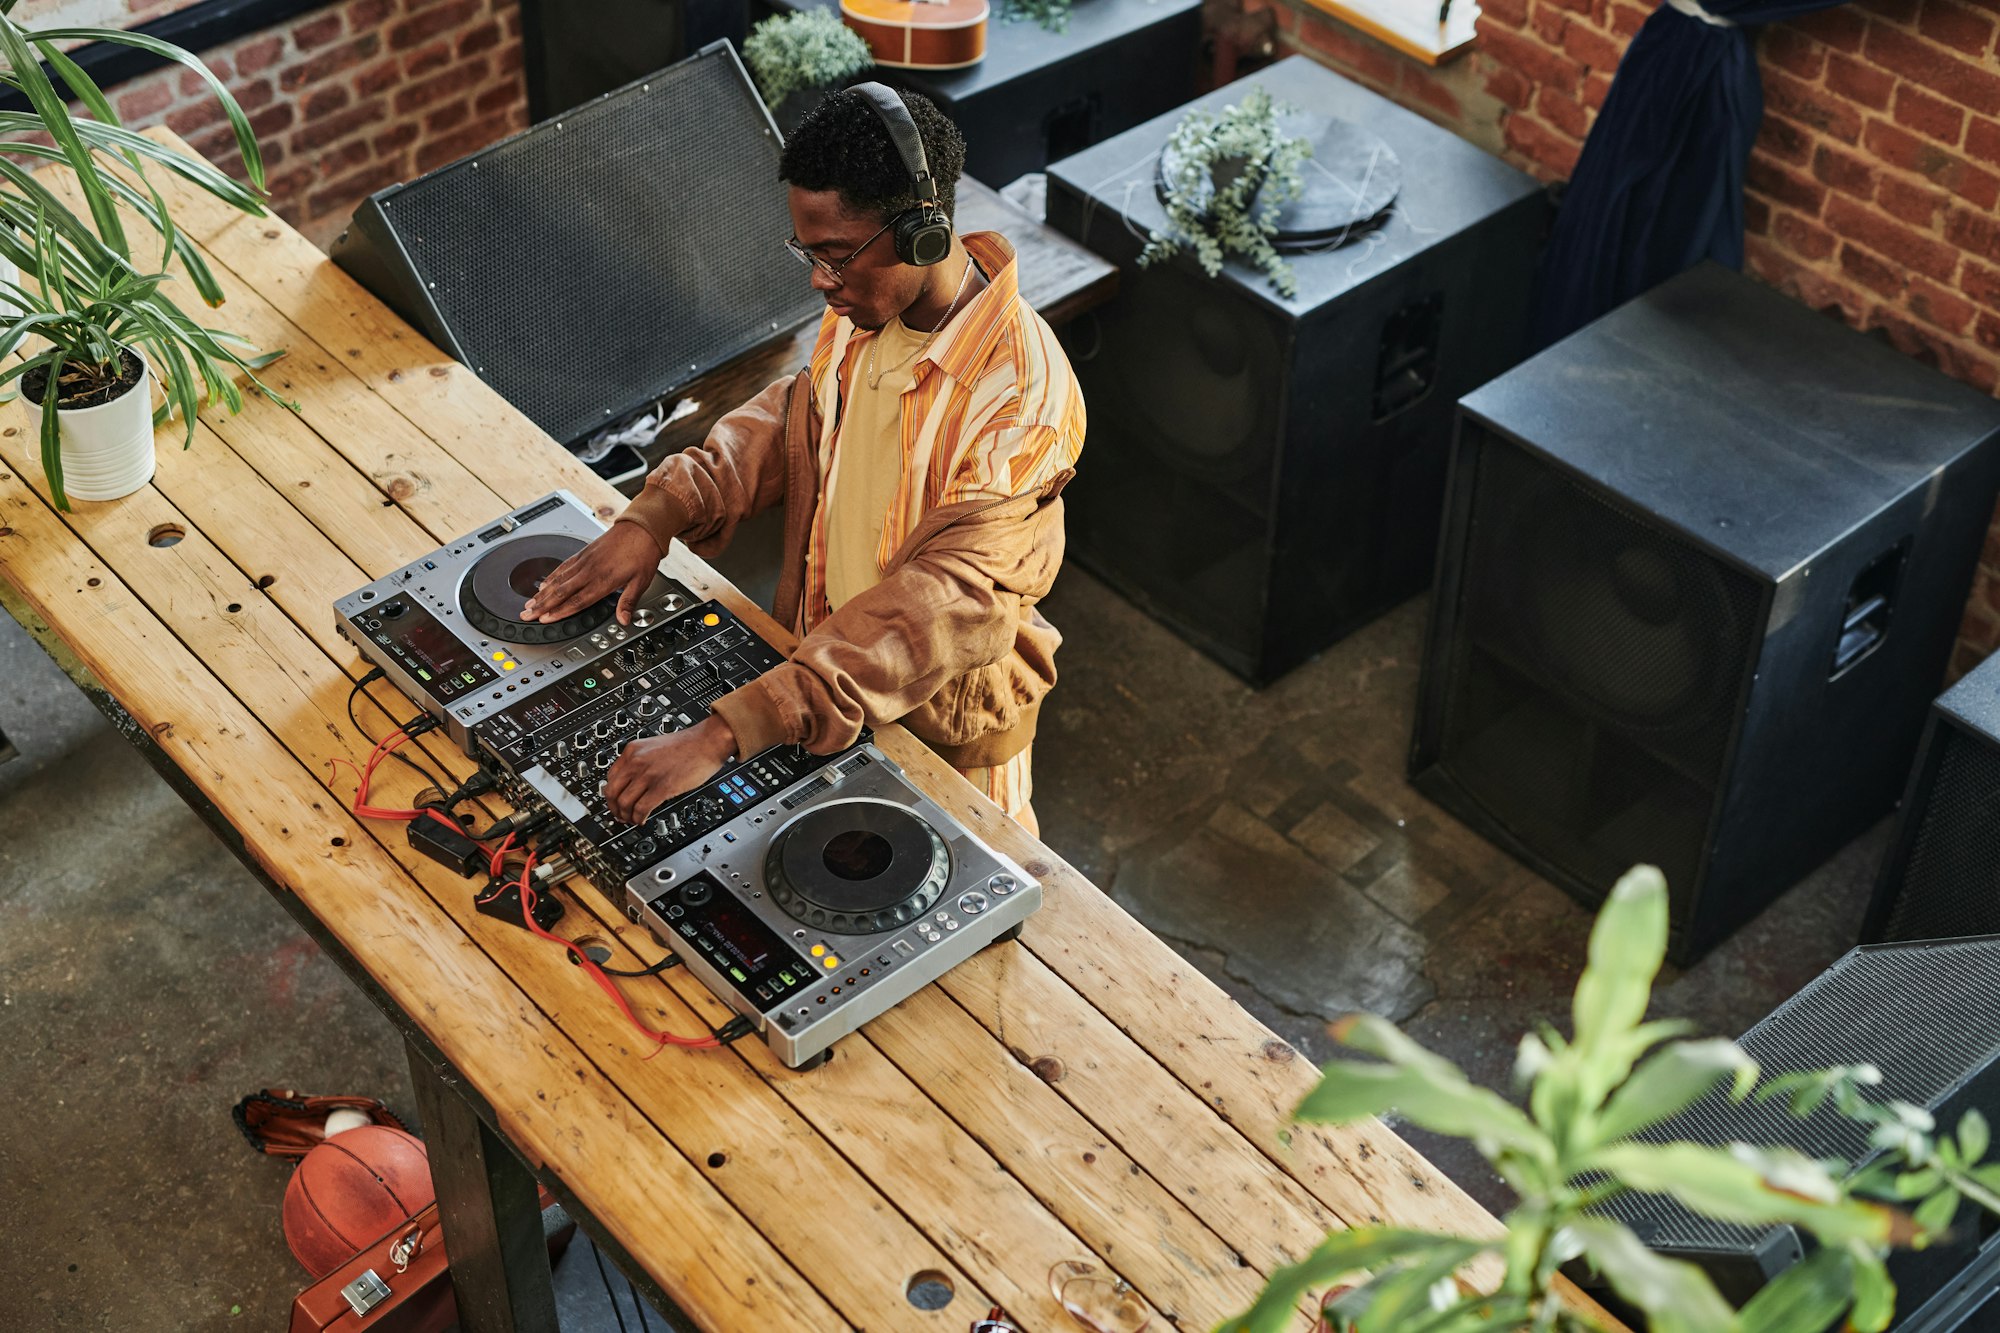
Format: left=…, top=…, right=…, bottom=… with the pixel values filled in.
left=284, top=1125, right=434, bottom=1277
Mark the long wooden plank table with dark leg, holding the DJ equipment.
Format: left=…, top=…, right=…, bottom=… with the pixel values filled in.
left=0, top=134, right=1494, bottom=1333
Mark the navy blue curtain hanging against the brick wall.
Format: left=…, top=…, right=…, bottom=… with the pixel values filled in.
left=1536, top=0, right=1842, bottom=346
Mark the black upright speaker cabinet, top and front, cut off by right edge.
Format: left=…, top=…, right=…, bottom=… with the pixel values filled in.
left=1862, top=656, right=2000, bottom=941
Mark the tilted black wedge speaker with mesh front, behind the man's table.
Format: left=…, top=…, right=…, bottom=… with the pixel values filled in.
left=332, top=42, right=820, bottom=444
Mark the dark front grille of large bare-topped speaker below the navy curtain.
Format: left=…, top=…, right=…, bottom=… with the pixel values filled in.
left=1438, top=422, right=1760, bottom=903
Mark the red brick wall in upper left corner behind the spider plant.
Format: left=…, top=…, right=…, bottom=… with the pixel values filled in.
left=72, top=0, right=528, bottom=246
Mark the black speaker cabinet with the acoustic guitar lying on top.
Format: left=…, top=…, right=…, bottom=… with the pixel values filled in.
left=768, top=0, right=1202, bottom=190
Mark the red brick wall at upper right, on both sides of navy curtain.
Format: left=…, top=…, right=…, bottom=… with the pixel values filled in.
left=1244, top=0, right=2000, bottom=675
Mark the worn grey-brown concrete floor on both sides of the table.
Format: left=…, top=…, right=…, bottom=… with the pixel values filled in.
left=0, top=532, right=1886, bottom=1331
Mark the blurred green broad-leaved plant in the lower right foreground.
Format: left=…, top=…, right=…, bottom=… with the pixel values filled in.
left=1222, top=867, right=1904, bottom=1333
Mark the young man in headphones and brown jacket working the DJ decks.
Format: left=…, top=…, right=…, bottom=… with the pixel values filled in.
left=522, top=84, right=1084, bottom=829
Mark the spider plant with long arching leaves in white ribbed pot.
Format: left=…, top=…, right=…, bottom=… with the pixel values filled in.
left=0, top=0, right=294, bottom=508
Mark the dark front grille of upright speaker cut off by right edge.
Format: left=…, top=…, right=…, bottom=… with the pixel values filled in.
left=1882, top=723, right=2000, bottom=939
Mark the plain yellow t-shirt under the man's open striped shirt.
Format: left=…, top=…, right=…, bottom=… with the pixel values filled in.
left=826, top=318, right=930, bottom=610
